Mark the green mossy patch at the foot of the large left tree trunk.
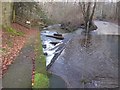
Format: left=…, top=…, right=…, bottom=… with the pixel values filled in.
left=3, top=26, right=24, bottom=36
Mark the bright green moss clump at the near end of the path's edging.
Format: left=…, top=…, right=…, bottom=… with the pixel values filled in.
left=33, top=73, right=49, bottom=88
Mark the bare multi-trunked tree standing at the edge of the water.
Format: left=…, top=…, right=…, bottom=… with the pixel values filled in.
left=79, top=2, right=97, bottom=33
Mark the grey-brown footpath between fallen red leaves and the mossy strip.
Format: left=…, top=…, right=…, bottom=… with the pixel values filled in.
left=2, top=26, right=37, bottom=88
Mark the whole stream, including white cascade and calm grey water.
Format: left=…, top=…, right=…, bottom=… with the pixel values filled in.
left=41, top=21, right=120, bottom=88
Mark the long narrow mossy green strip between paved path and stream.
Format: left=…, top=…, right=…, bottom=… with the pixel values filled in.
left=33, top=33, right=49, bottom=88
